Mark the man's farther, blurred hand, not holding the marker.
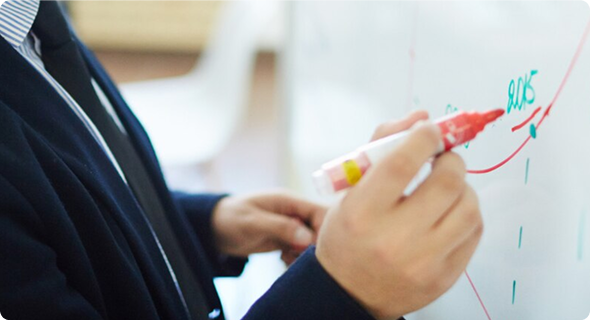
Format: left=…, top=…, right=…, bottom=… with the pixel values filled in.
left=212, top=193, right=326, bottom=264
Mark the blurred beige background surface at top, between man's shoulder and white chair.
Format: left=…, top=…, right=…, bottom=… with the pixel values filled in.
left=67, top=0, right=224, bottom=53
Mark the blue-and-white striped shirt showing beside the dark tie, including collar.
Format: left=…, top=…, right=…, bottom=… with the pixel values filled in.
left=0, top=0, right=127, bottom=182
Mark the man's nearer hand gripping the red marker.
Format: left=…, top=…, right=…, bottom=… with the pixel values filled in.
left=316, top=113, right=483, bottom=319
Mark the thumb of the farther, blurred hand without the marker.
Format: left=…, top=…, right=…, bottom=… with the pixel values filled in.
left=261, top=213, right=316, bottom=251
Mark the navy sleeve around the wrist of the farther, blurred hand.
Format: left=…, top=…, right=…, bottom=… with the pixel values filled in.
left=173, top=193, right=248, bottom=277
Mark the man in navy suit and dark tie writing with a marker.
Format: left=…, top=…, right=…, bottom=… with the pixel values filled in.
left=0, top=0, right=482, bottom=319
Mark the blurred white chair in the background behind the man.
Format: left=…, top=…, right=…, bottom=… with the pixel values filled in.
left=121, top=0, right=275, bottom=167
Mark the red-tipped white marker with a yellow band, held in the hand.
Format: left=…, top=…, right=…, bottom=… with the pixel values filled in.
left=313, top=109, right=504, bottom=194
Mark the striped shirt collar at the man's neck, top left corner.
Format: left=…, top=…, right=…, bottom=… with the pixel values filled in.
left=0, top=0, right=40, bottom=48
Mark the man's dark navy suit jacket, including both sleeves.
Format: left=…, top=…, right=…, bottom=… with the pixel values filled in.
left=0, top=33, right=370, bottom=319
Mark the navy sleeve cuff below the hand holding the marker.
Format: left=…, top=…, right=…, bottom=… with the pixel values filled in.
left=244, top=248, right=374, bottom=320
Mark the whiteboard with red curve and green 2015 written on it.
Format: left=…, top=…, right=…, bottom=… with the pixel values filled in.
left=285, top=0, right=590, bottom=320
